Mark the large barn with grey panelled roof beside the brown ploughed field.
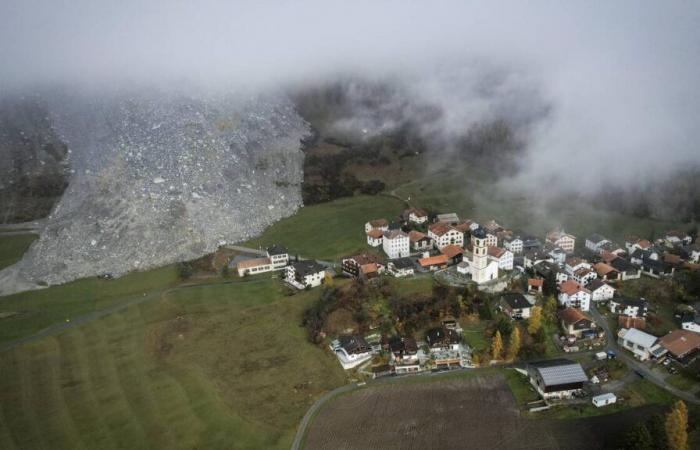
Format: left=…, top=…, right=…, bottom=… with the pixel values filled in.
left=527, top=359, right=588, bottom=399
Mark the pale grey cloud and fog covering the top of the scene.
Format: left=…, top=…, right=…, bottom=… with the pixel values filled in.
left=0, top=0, right=700, bottom=186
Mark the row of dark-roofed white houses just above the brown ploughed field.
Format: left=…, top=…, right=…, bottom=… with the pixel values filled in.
left=330, top=319, right=472, bottom=377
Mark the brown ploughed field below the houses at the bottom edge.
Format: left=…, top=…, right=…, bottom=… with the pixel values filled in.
left=306, top=374, right=655, bottom=449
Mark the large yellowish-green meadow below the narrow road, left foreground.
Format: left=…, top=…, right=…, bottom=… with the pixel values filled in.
left=0, top=280, right=345, bottom=449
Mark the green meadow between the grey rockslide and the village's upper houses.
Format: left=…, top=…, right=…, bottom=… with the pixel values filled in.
left=242, top=195, right=405, bottom=260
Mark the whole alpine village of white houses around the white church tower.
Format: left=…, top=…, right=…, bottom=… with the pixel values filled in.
left=230, top=207, right=700, bottom=411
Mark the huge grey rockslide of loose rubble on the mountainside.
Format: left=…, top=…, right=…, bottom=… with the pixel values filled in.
left=0, top=92, right=308, bottom=294
